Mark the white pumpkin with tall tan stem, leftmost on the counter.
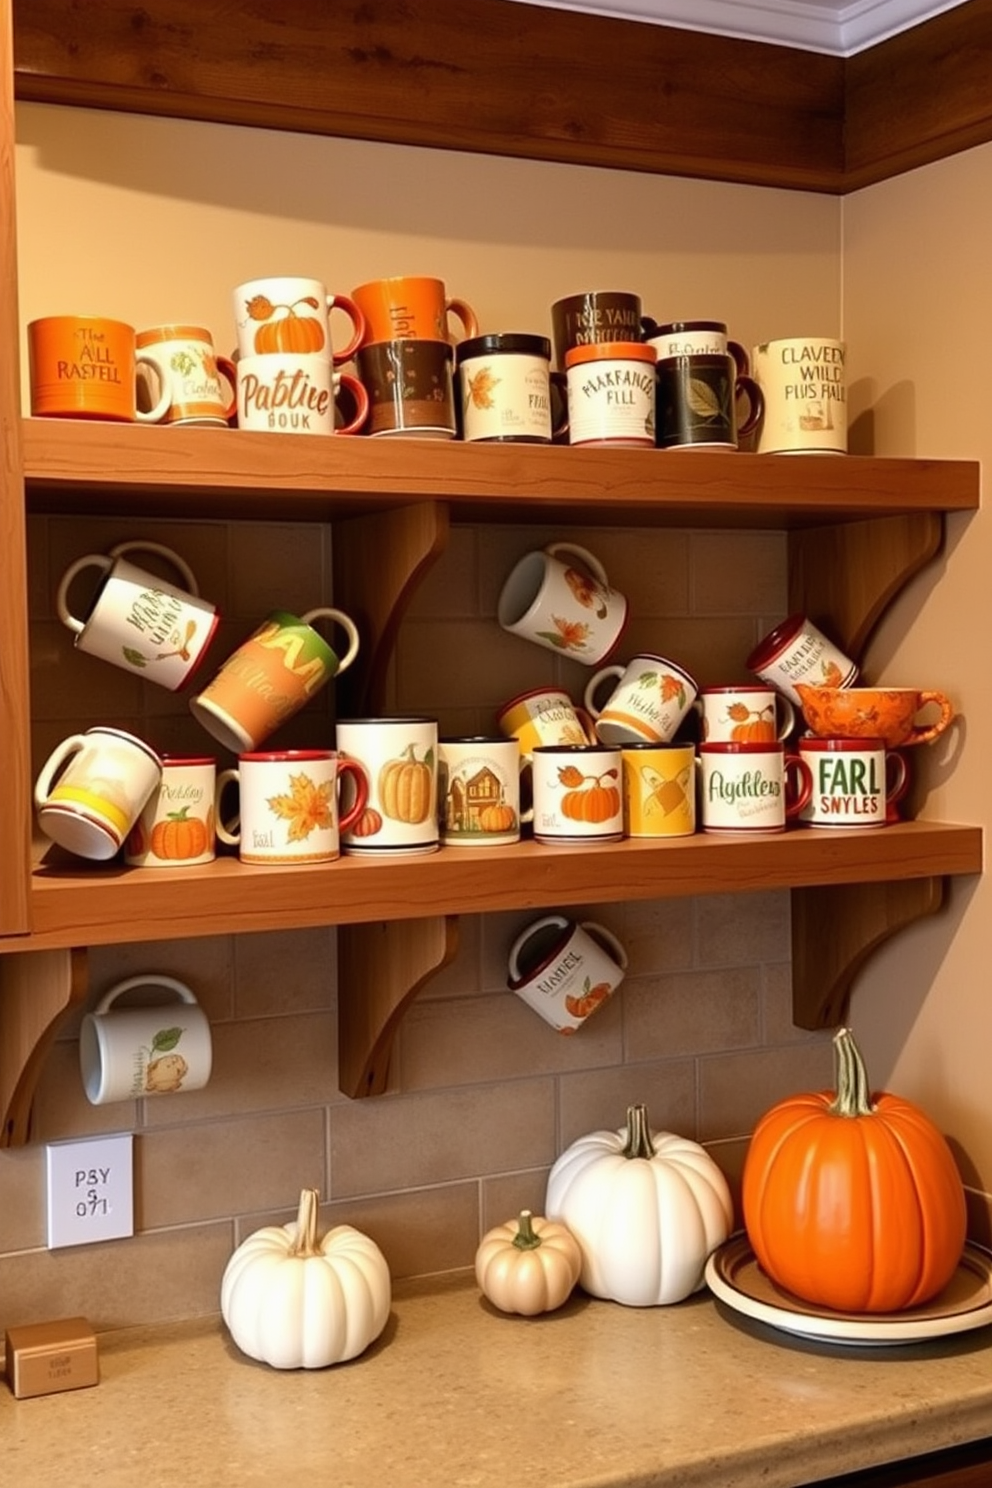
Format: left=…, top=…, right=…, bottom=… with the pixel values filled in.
left=220, top=1189, right=391, bottom=1369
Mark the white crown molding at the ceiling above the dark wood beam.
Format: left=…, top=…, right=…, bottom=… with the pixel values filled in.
left=518, top=0, right=962, bottom=57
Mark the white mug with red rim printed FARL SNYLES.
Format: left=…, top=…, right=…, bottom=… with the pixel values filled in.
left=799, top=737, right=909, bottom=827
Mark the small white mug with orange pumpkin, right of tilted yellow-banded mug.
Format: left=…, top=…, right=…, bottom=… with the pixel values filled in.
left=123, top=754, right=217, bottom=868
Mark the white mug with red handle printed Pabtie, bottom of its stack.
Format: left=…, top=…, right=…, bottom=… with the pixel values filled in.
left=236, top=351, right=369, bottom=434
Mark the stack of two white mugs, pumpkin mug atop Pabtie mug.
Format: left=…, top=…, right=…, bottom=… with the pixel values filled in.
left=233, top=275, right=369, bottom=434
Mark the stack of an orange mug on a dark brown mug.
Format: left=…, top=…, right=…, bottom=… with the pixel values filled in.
left=351, top=275, right=479, bottom=439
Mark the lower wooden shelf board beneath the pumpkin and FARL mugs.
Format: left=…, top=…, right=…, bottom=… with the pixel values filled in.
left=11, top=821, right=982, bottom=951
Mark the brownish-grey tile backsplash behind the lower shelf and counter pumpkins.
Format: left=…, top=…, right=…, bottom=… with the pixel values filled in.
left=0, top=505, right=831, bottom=1329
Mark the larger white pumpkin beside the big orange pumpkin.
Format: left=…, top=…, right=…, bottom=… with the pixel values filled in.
left=544, top=1106, right=733, bottom=1306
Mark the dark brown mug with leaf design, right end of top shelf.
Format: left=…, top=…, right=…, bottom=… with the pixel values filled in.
left=656, top=353, right=764, bottom=449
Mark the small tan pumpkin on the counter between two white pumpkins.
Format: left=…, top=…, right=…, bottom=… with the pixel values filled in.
left=476, top=1210, right=582, bottom=1317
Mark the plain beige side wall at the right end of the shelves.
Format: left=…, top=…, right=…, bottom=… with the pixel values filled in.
left=843, top=146, right=992, bottom=1192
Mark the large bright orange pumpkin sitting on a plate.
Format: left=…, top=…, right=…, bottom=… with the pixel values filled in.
left=742, top=1028, right=965, bottom=1312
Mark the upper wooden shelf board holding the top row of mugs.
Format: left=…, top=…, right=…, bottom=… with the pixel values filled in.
left=22, top=418, right=979, bottom=528
